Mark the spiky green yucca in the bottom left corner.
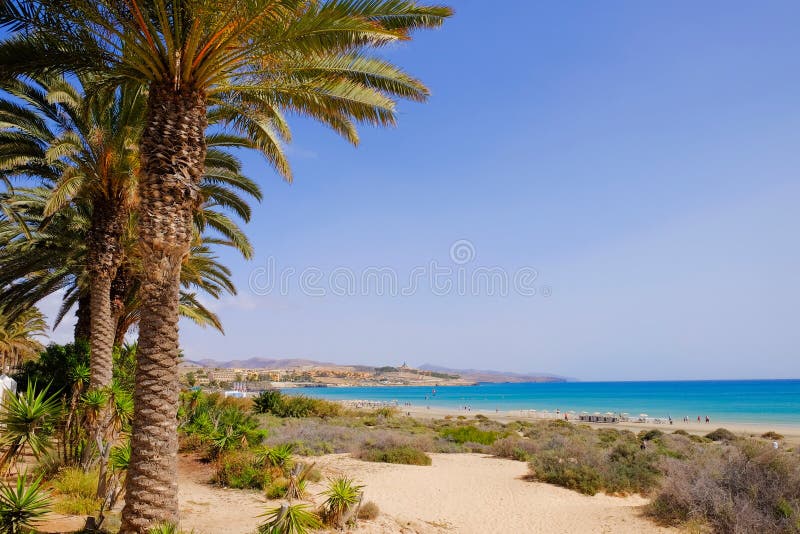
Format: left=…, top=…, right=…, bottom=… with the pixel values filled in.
left=0, top=473, right=50, bottom=534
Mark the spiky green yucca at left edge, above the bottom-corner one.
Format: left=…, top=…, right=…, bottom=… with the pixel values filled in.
left=0, top=382, right=61, bottom=473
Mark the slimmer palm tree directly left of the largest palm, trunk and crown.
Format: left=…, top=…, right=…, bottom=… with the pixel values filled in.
left=0, top=76, right=145, bottom=388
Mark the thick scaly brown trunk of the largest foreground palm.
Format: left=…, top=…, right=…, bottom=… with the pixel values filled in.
left=120, top=85, right=207, bottom=534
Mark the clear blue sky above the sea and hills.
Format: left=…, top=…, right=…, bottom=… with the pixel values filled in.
left=47, top=0, right=800, bottom=380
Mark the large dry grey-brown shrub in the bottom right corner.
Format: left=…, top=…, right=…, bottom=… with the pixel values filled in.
left=650, top=441, right=800, bottom=533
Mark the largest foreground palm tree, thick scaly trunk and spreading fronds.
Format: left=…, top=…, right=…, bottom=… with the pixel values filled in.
left=0, top=0, right=451, bottom=533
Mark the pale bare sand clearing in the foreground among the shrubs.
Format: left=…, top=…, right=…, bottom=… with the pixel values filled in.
left=179, top=454, right=668, bottom=534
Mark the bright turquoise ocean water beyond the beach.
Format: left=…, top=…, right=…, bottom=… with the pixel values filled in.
left=284, top=380, right=800, bottom=425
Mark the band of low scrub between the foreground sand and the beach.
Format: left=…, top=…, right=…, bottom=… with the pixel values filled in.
left=181, top=391, right=800, bottom=532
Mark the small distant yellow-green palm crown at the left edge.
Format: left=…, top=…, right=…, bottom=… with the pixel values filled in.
left=0, top=308, right=47, bottom=374
